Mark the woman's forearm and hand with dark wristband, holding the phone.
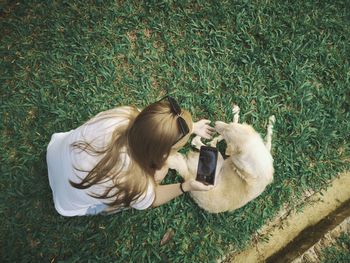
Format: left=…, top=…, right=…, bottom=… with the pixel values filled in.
left=152, top=179, right=214, bottom=207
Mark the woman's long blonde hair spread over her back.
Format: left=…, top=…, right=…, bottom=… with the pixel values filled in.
left=70, top=100, right=192, bottom=208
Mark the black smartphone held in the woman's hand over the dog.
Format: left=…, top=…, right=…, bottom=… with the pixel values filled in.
left=196, top=146, right=218, bottom=185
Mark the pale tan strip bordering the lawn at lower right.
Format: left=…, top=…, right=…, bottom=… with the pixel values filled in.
left=223, top=172, right=350, bottom=263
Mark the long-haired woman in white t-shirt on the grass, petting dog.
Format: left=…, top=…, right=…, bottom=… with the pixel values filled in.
left=47, top=97, right=213, bottom=216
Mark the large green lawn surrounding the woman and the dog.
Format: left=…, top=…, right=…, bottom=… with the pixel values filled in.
left=0, top=0, right=350, bottom=262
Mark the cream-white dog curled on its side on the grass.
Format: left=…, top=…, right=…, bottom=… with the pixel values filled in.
left=168, top=106, right=275, bottom=213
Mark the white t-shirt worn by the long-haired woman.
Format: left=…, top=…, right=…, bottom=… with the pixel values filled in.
left=46, top=107, right=155, bottom=216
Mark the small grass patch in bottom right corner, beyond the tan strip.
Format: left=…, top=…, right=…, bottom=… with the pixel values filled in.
left=321, top=233, right=350, bottom=263
